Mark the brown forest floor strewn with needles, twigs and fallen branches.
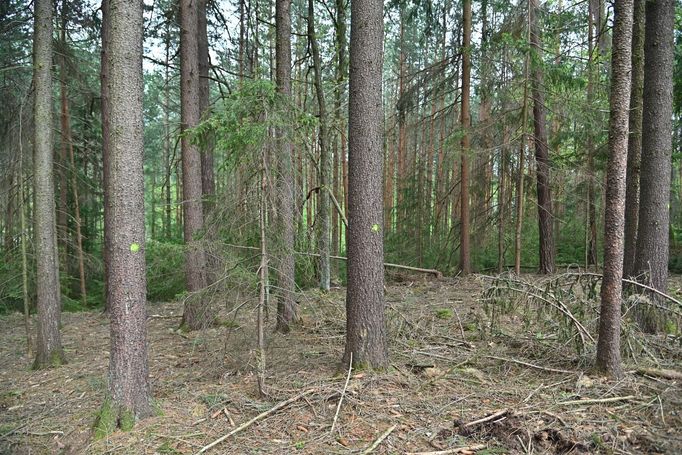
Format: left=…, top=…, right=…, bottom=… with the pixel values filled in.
left=0, top=276, right=682, bottom=454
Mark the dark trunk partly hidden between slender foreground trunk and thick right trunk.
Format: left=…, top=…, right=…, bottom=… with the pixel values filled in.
left=623, top=0, right=646, bottom=277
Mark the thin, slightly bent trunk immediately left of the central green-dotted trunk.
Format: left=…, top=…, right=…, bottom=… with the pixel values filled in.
left=308, top=0, right=332, bottom=291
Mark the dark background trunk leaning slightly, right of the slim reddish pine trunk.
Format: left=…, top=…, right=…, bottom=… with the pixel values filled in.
left=530, top=0, right=555, bottom=273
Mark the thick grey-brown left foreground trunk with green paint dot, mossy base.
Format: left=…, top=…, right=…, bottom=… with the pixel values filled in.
left=100, top=0, right=151, bottom=427
